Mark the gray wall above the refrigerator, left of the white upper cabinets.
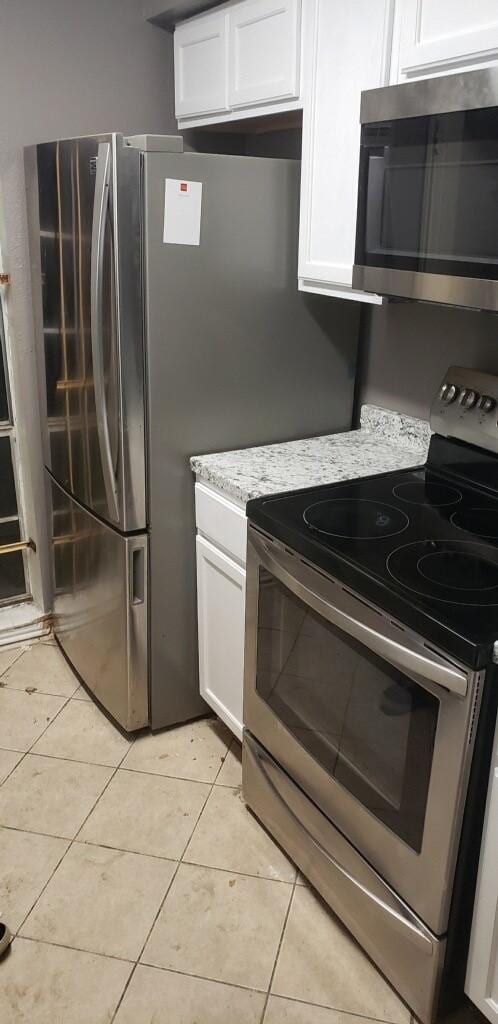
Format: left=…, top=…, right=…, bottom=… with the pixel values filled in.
left=0, top=0, right=174, bottom=150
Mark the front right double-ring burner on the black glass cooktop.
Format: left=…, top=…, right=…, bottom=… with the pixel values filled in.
left=386, top=540, right=498, bottom=606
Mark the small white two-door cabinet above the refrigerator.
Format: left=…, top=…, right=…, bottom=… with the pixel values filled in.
left=174, top=0, right=301, bottom=128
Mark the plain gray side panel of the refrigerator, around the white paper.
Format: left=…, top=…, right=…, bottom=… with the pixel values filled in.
left=143, top=153, right=359, bottom=728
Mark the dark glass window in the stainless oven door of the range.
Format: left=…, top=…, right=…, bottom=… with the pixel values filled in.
left=256, top=568, right=440, bottom=852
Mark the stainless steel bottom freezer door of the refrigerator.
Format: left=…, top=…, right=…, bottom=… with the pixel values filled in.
left=49, top=477, right=149, bottom=731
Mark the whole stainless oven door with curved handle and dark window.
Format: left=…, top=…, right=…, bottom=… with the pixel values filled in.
left=244, top=526, right=484, bottom=935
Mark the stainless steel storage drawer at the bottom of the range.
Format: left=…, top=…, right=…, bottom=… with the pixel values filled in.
left=242, top=729, right=446, bottom=1024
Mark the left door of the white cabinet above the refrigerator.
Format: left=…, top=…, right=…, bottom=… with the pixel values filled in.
left=174, top=12, right=229, bottom=118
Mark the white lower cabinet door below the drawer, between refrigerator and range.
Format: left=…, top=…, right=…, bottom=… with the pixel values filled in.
left=197, top=536, right=246, bottom=739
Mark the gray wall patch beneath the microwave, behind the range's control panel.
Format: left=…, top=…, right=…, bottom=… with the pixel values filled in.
left=358, top=302, right=498, bottom=419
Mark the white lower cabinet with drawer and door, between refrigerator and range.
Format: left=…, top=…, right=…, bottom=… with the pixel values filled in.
left=196, top=484, right=247, bottom=739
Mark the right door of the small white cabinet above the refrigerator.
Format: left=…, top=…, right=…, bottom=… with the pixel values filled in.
left=229, top=0, right=301, bottom=108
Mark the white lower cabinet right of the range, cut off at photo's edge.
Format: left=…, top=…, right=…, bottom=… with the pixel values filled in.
left=465, top=727, right=498, bottom=1024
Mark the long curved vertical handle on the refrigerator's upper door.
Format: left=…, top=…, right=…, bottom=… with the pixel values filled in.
left=90, top=142, right=120, bottom=522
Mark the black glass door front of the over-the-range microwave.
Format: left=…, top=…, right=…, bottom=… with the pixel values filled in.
left=356, top=108, right=498, bottom=280
